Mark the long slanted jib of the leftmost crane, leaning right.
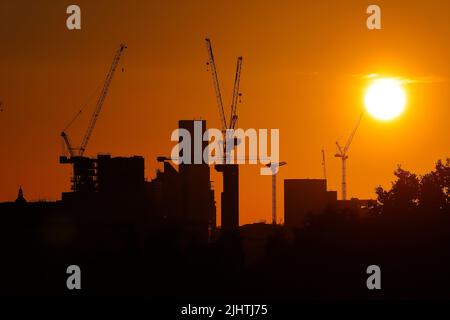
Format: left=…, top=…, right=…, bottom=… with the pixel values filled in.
left=80, top=44, right=127, bottom=156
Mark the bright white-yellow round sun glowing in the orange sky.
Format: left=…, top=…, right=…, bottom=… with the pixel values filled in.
left=364, top=78, right=406, bottom=120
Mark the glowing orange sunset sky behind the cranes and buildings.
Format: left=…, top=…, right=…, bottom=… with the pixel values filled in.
left=0, top=0, right=450, bottom=224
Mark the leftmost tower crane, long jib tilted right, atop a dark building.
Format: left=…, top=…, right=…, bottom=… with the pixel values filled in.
left=61, top=44, right=127, bottom=158
